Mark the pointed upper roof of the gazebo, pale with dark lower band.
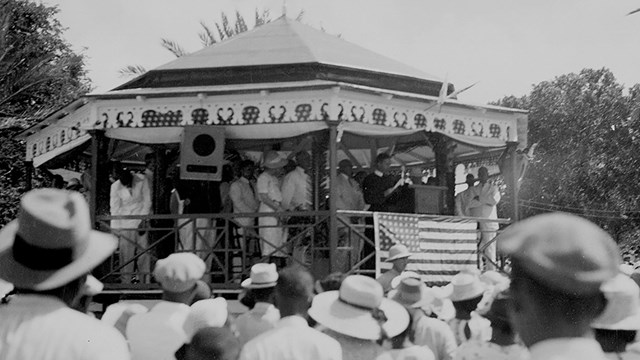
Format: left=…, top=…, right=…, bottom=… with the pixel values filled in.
left=115, top=17, right=453, bottom=96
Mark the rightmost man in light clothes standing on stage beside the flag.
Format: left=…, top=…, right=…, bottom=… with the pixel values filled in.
left=467, top=166, right=500, bottom=270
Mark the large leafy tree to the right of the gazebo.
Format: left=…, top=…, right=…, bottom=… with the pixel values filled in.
left=497, top=69, right=640, bottom=237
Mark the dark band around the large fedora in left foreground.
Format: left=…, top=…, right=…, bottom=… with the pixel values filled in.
left=12, top=234, right=73, bottom=270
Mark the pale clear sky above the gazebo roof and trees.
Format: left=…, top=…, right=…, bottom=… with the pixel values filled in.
left=39, top=0, right=640, bottom=104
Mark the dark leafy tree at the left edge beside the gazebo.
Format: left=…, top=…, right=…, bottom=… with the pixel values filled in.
left=0, top=0, right=90, bottom=224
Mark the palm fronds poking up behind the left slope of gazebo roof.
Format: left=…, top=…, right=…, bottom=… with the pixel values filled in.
left=118, top=9, right=272, bottom=77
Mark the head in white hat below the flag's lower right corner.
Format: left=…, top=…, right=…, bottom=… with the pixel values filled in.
left=449, top=271, right=486, bottom=320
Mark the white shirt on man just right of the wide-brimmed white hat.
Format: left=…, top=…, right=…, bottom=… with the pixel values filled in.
left=413, top=315, right=458, bottom=360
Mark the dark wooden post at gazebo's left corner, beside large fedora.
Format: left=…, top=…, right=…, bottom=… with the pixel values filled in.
left=89, top=130, right=111, bottom=225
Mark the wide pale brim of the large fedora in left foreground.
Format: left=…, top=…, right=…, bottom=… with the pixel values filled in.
left=0, top=220, right=118, bottom=291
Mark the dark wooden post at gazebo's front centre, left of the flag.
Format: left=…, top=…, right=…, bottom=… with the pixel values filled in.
left=329, top=122, right=340, bottom=273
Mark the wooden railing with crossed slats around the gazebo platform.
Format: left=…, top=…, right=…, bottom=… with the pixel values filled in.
left=96, top=211, right=509, bottom=291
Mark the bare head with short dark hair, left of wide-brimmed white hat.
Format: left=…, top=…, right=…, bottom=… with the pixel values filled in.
left=275, top=266, right=313, bottom=318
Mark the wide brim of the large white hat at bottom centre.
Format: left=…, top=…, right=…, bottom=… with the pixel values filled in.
left=309, top=290, right=409, bottom=340
